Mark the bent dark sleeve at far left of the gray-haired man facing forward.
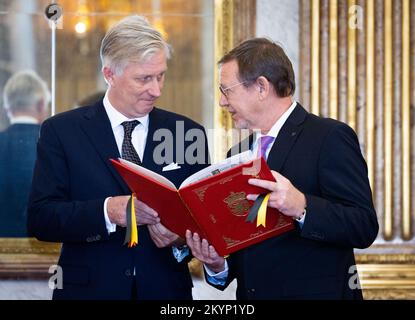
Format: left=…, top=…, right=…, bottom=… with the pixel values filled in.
left=27, top=121, right=108, bottom=242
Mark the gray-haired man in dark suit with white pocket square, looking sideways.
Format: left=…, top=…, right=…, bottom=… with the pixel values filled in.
left=28, top=16, right=208, bottom=300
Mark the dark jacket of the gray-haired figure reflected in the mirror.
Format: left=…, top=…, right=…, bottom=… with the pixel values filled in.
left=0, top=124, right=40, bottom=237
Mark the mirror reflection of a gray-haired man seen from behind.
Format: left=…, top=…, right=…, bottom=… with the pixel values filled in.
left=0, top=70, right=49, bottom=237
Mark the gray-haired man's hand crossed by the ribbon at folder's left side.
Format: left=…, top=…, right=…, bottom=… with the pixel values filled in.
left=107, top=196, right=160, bottom=227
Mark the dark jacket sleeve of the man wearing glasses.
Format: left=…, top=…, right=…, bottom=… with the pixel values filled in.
left=301, top=124, right=379, bottom=248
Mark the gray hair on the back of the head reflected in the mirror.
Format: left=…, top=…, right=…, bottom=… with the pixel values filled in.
left=3, top=70, right=50, bottom=112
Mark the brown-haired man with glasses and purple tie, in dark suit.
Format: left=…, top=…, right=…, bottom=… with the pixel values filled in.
left=186, top=38, right=378, bottom=299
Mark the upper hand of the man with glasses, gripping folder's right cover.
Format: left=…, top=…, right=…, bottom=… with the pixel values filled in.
left=246, top=171, right=307, bottom=218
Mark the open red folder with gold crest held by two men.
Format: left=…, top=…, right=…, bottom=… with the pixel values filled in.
left=111, top=154, right=294, bottom=255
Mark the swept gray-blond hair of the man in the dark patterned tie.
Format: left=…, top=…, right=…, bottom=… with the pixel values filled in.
left=100, top=15, right=171, bottom=74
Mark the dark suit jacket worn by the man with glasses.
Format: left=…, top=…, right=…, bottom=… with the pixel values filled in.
left=218, top=105, right=378, bottom=299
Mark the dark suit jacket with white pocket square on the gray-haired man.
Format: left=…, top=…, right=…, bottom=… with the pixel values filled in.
left=28, top=101, right=208, bottom=299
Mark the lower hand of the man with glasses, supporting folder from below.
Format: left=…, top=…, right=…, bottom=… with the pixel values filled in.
left=186, top=230, right=225, bottom=273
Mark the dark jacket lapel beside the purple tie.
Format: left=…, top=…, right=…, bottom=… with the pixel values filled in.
left=267, top=104, right=307, bottom=171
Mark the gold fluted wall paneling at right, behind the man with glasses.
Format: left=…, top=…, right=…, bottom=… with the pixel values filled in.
left=300, top=0, right=415, bottom=299
